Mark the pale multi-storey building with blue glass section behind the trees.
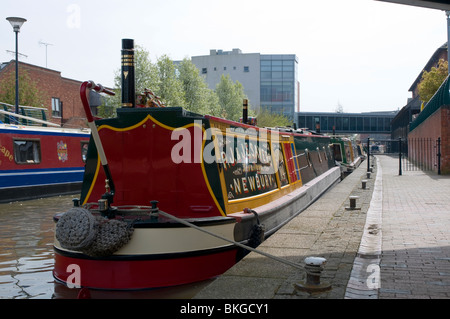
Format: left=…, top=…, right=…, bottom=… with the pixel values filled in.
left=191, top=49, right=300, bottom=119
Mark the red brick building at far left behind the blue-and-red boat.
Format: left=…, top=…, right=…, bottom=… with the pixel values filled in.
left=0, top=60, right=87, bottom=127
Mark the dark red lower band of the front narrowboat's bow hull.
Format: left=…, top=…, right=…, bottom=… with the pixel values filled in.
left=53, top=248, right=237, bottom=290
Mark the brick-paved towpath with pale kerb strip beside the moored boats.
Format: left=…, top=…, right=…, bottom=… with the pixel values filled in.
left=195, top=155, right=450, bottom=299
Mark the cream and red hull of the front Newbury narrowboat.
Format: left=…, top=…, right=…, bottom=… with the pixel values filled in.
left=53, top=167, right=340, bottom=290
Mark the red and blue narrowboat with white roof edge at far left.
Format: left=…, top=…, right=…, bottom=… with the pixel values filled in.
left=0, top=103, right=90, bottom=203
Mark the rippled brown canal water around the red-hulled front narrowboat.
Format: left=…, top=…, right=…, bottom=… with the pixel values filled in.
left=0, top=195, right=210, bottom=299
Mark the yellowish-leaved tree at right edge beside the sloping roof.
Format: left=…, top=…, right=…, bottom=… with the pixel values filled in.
left=418, top=59, right=448, bottom=102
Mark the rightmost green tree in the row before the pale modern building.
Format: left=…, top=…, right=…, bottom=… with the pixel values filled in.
left=216, top=74, right=246, bottom=121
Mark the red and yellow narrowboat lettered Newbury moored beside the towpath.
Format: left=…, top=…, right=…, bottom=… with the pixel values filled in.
left=53, top=39, right=340, bottom=290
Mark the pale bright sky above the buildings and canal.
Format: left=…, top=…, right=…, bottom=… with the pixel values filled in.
left=0, top=0, right=447, bottom=113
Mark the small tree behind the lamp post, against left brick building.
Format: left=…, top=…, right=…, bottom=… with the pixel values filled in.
left=0, top=69, right=44, bottom=107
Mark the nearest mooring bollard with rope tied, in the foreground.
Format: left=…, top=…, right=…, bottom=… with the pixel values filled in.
left=295, top=257, right=331, bottom=292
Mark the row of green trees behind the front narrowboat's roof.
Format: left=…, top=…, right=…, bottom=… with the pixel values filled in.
left=111, top=46, right=252, bottom=121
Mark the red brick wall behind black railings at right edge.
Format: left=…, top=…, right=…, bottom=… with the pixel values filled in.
left=408, top=105, right=450, bottom=174
